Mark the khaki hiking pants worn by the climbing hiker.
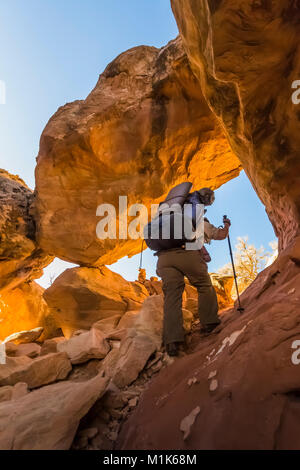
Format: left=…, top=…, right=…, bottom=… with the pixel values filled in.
left=157, top=248, right=220, bottom=345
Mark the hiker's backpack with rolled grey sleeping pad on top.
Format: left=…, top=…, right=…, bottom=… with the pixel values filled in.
left=144, top=182, right=193, bottom=251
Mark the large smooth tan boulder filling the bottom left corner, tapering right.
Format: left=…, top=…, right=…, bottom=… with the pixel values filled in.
left=0, top=376, right=107, bottom=450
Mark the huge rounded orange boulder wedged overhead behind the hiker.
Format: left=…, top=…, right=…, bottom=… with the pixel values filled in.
left=36, top=39, right=241, bottom=266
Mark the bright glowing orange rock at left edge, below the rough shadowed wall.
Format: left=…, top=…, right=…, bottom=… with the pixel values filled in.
left=0, top=282, right=57, bottom=341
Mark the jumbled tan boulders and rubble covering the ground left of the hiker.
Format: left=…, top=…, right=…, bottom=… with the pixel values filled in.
left=0, top=280, right=221, bottom=449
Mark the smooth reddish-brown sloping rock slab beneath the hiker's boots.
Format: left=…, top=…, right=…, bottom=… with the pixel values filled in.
left=117, top=238, right=300, bottom=450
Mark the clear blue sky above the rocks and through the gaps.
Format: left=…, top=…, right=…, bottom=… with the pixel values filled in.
left=0, top=0, right=275, bottom=286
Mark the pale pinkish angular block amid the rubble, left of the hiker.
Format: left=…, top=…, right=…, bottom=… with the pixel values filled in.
left=57, top=328, right=110, bottom=364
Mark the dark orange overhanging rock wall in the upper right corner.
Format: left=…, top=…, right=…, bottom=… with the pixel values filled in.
left=172, top=0, right=300, bottom=249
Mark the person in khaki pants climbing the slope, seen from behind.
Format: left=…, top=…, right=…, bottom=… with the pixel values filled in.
left=145, top=183, right=230, bottom=356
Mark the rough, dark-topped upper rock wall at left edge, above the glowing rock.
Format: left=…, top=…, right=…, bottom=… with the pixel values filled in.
left=0, top=169, right=52, bottom=291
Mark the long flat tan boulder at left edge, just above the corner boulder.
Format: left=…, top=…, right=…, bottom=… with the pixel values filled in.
left=0, top=353, right=72, bottom=389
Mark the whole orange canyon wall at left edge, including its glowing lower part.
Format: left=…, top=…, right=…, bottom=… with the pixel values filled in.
left=0, top=169, right=55, bottom=340
